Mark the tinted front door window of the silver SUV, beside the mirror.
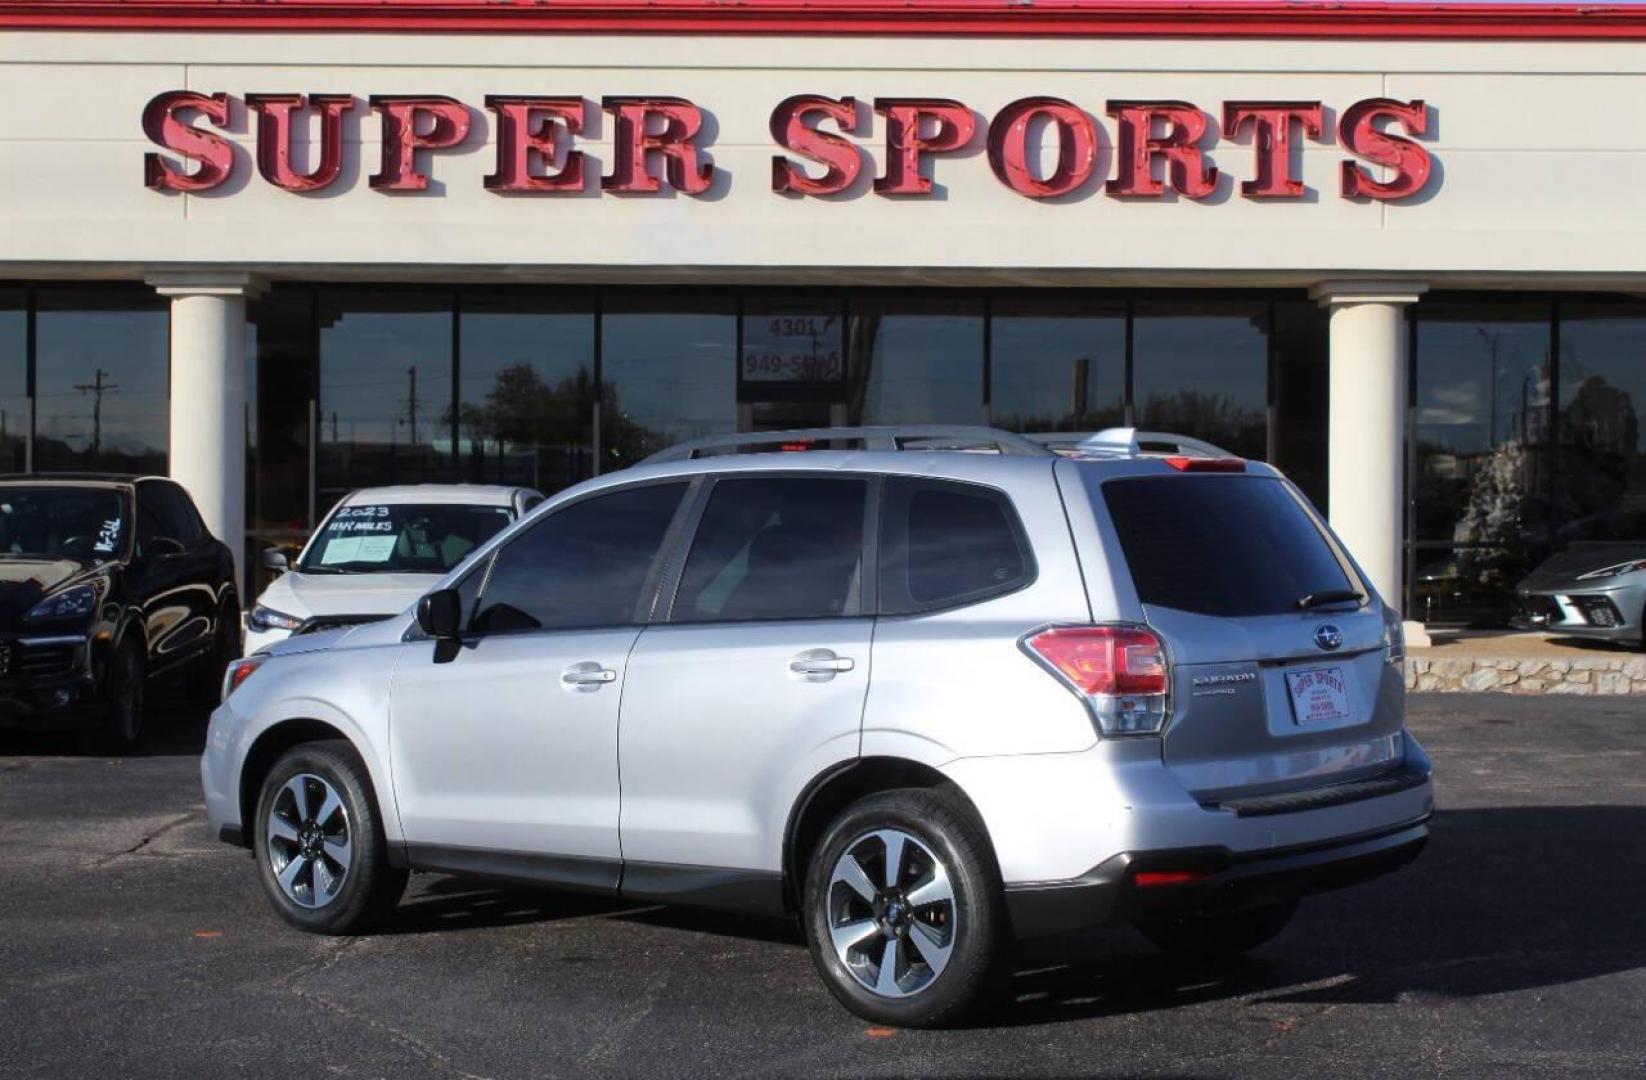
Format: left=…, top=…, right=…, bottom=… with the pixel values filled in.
left=471, top=481, right=686, bottom=634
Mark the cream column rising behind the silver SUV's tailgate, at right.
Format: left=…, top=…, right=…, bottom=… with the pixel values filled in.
left=1310, top=282, right=1427, bottom=637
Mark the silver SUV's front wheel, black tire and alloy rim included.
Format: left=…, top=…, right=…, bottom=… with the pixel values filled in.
left=252, top=739, right=407, bottom=933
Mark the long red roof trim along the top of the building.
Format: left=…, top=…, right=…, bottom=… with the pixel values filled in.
left=0, top=0, right=1646, bottom=41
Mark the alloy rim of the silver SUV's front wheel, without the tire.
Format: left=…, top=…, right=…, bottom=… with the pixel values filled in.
left=267, top=772, right=354, bottom=909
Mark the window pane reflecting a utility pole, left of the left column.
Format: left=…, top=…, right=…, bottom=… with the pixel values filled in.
left=35, top=288, right=171, bottom=473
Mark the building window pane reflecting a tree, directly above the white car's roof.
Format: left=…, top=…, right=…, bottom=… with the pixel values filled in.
left=458, top=295, right=594, bottom=494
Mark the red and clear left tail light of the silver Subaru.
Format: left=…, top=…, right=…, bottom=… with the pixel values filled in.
left=1022, top=626, right=1170, bottom=734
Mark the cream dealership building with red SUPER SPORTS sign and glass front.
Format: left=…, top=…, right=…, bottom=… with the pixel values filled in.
left=0, top=0, right=1646, bottom=622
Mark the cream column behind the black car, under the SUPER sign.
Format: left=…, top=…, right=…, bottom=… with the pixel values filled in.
left=148, top=272, right=257, bottom=589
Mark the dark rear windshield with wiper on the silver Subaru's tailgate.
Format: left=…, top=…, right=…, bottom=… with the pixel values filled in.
left=1103, top=476, right=1360, bottom=616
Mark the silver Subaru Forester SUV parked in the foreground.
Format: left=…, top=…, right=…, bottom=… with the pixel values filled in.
left=202, top=428, right=1432, bottom=1024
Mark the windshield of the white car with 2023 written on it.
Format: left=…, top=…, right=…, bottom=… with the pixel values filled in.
left=298, top=502, right=514, bottom=575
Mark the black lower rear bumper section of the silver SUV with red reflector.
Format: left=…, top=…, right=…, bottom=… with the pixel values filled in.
left=1006, top=815, right=1429, bottom=937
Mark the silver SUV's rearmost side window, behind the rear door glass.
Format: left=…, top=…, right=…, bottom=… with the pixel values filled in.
left=881, top=476, right=1034, bottom=614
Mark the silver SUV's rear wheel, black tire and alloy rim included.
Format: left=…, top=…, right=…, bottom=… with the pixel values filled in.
left=803, top=789, right=1006, bottom=1027
